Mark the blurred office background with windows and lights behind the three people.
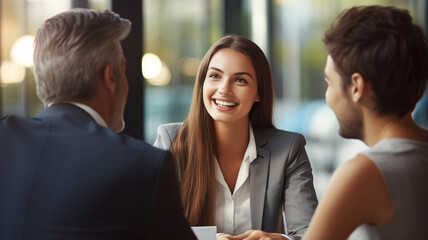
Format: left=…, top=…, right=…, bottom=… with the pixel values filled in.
left=0, top=0, right=428, bottom=198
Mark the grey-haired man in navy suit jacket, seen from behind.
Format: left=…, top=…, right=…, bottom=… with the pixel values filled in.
left=0, top=9, right=195, bottom=239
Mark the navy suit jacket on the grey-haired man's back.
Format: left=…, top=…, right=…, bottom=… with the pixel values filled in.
left=0, top=104, right=195, bottom=240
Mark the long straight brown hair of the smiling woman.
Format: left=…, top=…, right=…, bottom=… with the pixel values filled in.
left=172, top=35, right=274, bottom=226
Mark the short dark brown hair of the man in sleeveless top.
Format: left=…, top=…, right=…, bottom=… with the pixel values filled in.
left=324, top=6, right=428, bottom=116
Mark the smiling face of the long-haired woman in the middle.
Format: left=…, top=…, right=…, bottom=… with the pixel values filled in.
left=203, top=48, right=260, bottom=123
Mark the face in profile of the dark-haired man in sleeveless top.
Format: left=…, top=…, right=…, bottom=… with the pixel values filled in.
left=324, top=55, right=363, bottom=139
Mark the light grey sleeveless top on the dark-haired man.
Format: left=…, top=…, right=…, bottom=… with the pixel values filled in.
left=349, top=138, right=428, bottom=240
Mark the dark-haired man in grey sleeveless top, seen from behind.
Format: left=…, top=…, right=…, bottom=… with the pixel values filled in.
left=304, top=6, right=428, bottom=240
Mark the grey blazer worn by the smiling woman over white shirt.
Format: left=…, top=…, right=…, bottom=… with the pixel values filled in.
left=154, top=123, right=318, bottom=239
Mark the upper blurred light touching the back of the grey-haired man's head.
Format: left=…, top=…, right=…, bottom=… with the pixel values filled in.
left=10, top=35, right=34, bottom=67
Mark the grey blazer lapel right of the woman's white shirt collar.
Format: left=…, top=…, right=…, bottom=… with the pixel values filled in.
left=250, top=130, right=270, bottom=229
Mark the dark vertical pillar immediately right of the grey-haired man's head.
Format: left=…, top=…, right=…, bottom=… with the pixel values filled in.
left=112, top=0, right=144, bottom=139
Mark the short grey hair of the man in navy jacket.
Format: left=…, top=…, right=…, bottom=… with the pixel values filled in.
left=34, top=9, right=131, bottom=105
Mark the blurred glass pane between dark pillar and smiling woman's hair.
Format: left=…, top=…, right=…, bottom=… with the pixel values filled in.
left=142, top=0, right=222, bottom=143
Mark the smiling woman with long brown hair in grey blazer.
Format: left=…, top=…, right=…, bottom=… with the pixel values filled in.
left=154, top=35, right=317, bottom=239
